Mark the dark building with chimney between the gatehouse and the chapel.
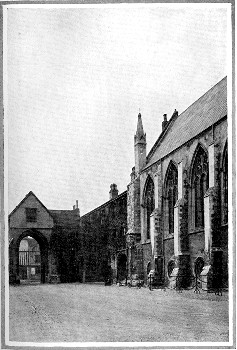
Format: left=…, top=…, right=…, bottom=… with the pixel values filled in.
left=81, top=184, right=127, bottom=281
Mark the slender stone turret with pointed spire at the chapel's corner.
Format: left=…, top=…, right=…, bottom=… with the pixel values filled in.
left=134, top=113, right=146, bottom=173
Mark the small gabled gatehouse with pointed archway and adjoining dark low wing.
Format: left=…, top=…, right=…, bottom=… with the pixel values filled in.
left=9, top=192, right=81, bottom=283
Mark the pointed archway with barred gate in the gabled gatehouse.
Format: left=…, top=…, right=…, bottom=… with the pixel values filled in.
left=9, top=229, right=48, bottom=283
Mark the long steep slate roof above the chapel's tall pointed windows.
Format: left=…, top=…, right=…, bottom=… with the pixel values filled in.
left=144, top=77, right=227, bottom=169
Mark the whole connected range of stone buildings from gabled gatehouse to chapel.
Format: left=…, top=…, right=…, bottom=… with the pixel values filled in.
left=9, top=78, right=228, bottom=289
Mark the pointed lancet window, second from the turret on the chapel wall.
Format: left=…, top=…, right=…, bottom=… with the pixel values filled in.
left=165, top=162, right=178, bottom=233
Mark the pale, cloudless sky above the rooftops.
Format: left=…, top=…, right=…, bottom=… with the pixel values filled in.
left=4, top=4, right=230, bottom=215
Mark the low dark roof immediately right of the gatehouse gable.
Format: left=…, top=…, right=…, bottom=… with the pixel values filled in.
left=49, top=209, right=80, bottom=226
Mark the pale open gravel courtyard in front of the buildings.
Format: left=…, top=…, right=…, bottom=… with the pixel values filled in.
left=10, top=284, right=228, bottom=342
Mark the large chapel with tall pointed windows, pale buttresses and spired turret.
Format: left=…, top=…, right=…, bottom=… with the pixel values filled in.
left=127, top=78, right=228, bottom=288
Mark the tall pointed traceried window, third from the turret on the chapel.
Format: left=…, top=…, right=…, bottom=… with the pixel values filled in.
left=192, top=146, right=209, bottom=228
